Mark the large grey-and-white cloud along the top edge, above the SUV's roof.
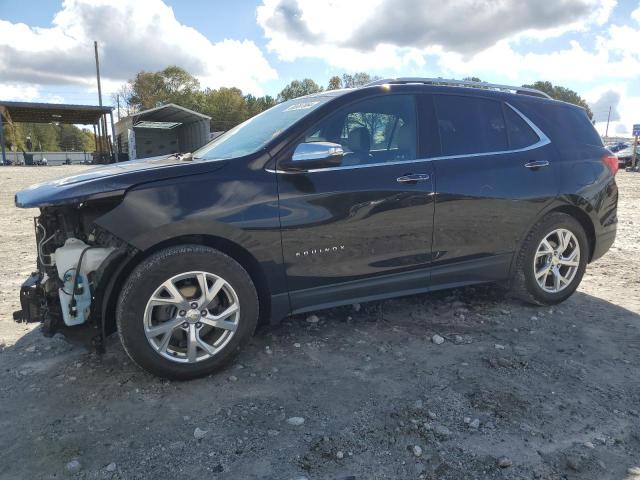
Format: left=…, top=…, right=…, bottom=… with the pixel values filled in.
left=257, top=0, right=615, bottom=61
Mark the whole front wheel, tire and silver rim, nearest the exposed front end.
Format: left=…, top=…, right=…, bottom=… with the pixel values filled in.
left=116, top=245, right=259, bottom=380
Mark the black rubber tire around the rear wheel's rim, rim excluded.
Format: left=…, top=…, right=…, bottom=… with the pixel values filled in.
left=511, top=212, right=589, bottom=305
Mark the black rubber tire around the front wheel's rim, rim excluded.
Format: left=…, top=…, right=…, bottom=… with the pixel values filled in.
left=116, top=245, right=259, bottom=380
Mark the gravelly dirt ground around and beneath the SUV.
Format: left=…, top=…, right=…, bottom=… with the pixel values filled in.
left=0, top=167, right=640, bottom=480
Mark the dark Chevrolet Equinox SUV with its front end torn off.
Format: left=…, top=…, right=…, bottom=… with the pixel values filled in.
left=16, top=79, right=618, bottom=379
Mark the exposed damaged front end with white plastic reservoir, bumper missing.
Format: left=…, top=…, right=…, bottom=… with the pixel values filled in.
left=14, top=198, right=135, bottom=344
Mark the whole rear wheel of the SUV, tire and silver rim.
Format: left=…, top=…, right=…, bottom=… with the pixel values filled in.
left=512, top=213, right=589, bottom=305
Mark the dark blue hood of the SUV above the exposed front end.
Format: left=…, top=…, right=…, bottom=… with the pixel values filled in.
left=15, top=155, right=227, bottom=208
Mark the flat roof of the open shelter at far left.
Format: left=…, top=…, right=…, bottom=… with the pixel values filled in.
left=0, top=100, right=113, bottom=125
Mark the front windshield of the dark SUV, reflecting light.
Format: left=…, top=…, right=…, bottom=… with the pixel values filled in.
left=193, top=96, right=333, bottom=160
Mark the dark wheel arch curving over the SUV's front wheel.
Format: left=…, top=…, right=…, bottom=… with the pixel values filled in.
left=101, top=234, right=271, bottom=336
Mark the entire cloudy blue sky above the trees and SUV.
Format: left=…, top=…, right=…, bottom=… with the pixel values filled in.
left=0, top=0, right=640, bottom=135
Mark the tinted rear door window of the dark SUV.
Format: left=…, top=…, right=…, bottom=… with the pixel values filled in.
left=434, top=95, right=509, bottom=155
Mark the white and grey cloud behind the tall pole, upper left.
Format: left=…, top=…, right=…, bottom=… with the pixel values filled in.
left=0, top=0, right=277, bottom=93
